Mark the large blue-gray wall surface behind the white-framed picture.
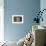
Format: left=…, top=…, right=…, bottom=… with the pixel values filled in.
left=4, top=0, right=40, bottom=41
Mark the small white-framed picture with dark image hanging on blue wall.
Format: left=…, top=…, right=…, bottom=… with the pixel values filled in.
left=12, top=15, right=24, bottom=24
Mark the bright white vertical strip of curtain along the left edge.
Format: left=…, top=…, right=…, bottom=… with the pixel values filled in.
left=0, top=0, right=4, bottom=42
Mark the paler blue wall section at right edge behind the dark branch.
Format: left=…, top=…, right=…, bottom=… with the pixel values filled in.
left=40, top=0, right=46, bottom=27
